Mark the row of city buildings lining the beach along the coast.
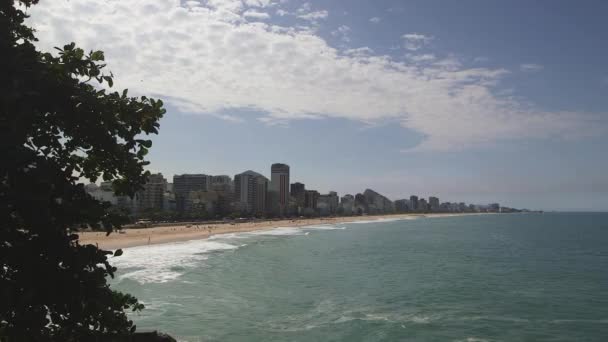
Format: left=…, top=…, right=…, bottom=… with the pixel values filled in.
left=85, top=163, right=514, bottom=219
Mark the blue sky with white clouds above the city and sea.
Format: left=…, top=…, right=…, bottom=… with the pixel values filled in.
left=28, top=0, right=608, bottom=211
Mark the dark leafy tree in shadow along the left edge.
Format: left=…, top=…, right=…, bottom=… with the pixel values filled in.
left=0, top=0, right=165, bottom=341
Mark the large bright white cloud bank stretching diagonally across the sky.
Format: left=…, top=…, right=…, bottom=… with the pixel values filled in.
left=29, top=0, right=606, bottom=150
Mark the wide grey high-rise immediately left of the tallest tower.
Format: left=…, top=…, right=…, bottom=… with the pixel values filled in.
left=234, top=170, right=268, bottom=214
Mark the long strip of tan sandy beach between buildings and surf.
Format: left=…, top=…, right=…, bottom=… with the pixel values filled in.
left=77, top=213, right=490, bottom=250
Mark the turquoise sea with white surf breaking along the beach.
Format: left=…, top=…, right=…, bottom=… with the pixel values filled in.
left=114, top=214, right=608, bottom=342
